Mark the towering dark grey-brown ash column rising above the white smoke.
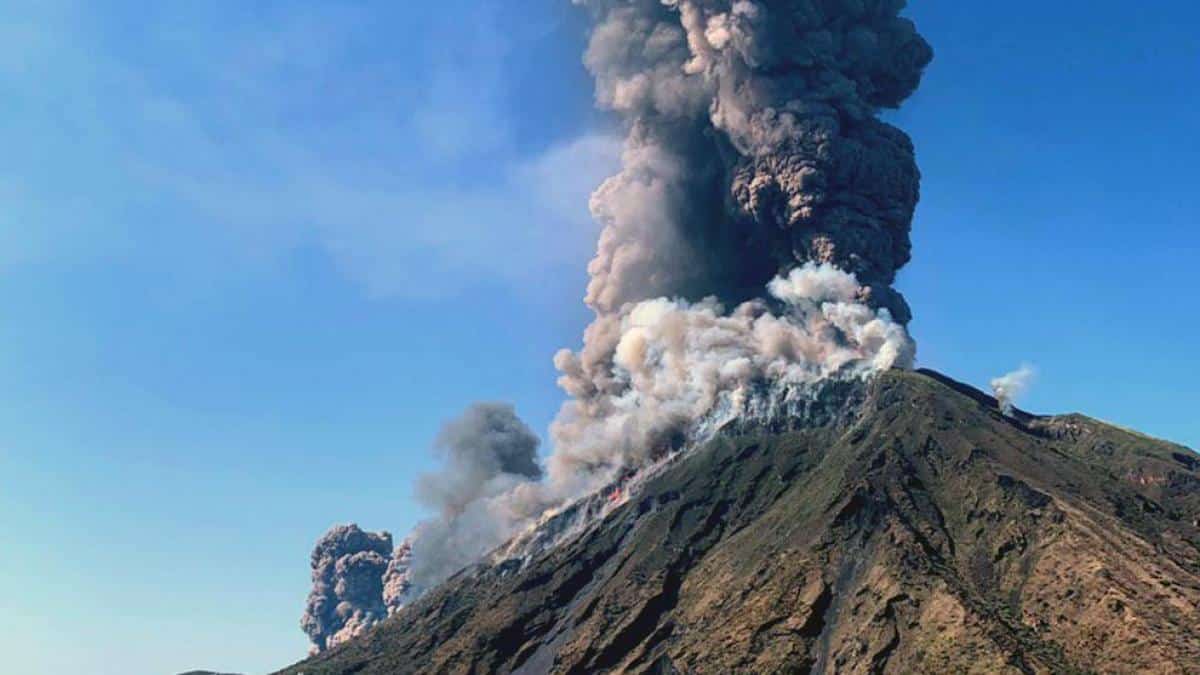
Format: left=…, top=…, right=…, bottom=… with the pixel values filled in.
left=577, top=0, right=932, bottom=323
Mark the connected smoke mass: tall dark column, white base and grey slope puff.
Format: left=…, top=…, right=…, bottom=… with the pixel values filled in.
left=302, top=0, right=932, bottom=653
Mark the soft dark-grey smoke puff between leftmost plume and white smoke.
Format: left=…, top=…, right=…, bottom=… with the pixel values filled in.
left=404, top=402, right=545, bottom=592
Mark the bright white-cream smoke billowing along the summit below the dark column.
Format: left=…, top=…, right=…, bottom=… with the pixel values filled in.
left=550, top=263, right=916, bottom=482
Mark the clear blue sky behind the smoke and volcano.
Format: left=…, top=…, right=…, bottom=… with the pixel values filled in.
left=0, top=0, right=1200, bottom=675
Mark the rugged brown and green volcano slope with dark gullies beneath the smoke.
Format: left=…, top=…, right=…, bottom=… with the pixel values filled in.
left=274, top=371, right=1200, bottom=675
